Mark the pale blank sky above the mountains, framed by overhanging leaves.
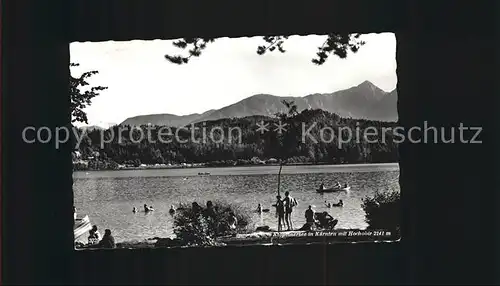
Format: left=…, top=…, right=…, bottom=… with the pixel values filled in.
left=70, top=33, right=397, bottom=127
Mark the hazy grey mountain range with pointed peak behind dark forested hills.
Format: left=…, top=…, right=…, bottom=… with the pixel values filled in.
left=120, top=81, right=398, bottom=127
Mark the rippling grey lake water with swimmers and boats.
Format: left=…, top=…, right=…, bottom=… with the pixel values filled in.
left=73, top=163, right=399, bottom=242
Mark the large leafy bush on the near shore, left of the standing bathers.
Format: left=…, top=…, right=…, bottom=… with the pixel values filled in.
left=174, top=202, right=253, bottom=246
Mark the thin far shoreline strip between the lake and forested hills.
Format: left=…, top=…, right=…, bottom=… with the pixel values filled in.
left=74, top=162, right=399, bottom=172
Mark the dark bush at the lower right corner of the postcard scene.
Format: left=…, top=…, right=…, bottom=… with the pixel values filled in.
left=361, top=191, right=401, bottom=230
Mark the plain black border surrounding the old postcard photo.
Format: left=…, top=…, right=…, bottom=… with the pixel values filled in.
left=1, top=0, right=500, bottom=285
